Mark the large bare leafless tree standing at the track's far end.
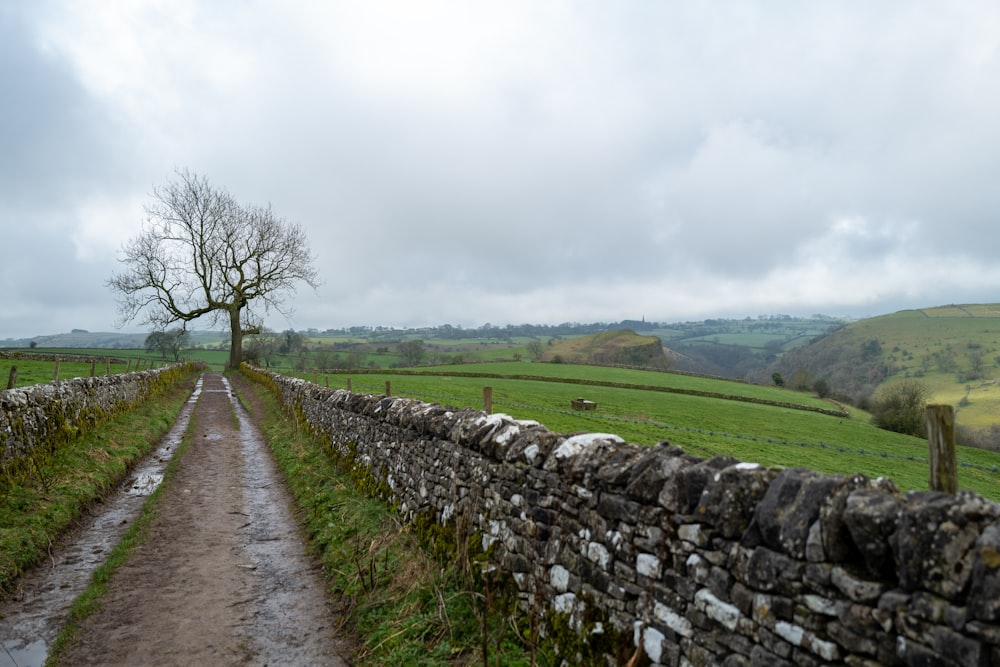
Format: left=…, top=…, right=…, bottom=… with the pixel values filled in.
left=107, top=170, right=319, bottom=367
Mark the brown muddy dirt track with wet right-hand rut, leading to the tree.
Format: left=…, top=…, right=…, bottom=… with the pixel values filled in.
left=55, top=373, right=348, bottom=665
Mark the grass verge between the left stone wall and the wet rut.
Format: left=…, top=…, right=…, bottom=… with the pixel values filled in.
left=0, top=373, right=197, bottom=595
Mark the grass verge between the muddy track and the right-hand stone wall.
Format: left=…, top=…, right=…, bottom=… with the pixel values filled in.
left=233, top=376, right=549, bottom=666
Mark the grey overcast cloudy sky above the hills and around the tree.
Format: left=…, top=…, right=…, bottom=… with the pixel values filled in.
left=0, top=0, right=1000, bottom=339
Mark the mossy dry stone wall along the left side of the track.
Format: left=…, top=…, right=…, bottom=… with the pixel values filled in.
left=0, top=364, right=193, bottom=466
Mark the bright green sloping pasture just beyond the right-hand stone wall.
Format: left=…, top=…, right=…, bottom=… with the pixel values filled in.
left=310, top=364, right=1000, bottom=501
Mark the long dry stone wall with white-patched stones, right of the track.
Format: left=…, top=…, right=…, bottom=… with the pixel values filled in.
left=253, top=371, right=1000, bottom=666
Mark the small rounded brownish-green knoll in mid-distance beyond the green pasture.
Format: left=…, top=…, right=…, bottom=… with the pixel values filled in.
left=541, top=329, right=670, bottom=368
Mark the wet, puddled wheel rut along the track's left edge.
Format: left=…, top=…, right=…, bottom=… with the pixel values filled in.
left=0, top=378, right=202, bottom=667
